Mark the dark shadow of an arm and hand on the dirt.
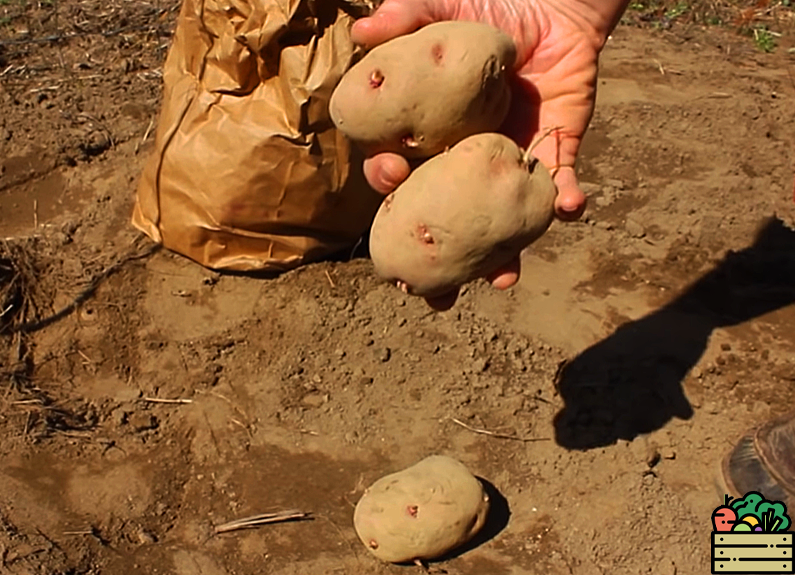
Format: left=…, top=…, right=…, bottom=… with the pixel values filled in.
left=554, top=218, right=795, bottom=449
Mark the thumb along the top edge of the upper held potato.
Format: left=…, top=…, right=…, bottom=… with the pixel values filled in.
left=351, top=0, right=440, bottom=48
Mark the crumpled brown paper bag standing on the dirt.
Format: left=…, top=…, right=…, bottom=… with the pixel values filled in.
left=132, top=0, right=380, bottom=272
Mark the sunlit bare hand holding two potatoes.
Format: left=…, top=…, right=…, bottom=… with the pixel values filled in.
left=352, top=0, right=627, bottom=310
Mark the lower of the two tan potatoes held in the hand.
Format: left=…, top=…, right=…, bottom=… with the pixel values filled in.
left=370, top=133, right=557, bottom=297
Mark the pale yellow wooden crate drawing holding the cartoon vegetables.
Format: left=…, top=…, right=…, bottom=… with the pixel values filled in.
left=712, top=531, right=795, bottom=575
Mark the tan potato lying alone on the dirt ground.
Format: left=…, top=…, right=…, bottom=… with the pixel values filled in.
left=353, top=455, right=490, bottom=563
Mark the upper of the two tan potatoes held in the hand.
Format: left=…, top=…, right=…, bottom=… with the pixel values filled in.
left=329, top=22, right=516, bottom=158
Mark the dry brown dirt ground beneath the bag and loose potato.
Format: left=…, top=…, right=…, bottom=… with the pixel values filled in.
left=0, top=0, right=795, bottom=575
